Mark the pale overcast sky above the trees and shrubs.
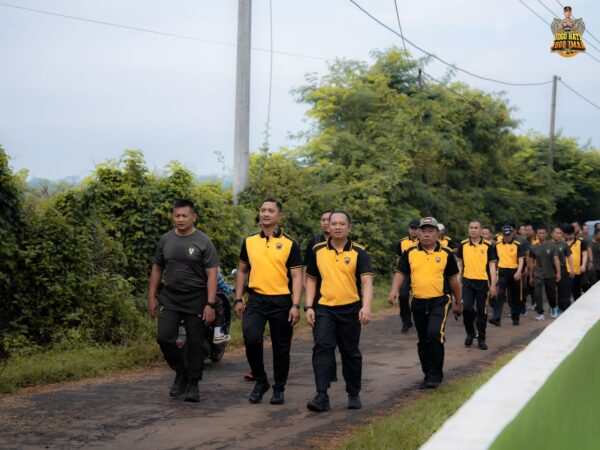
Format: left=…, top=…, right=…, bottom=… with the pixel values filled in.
left=0, top=0, right=600, bottom=180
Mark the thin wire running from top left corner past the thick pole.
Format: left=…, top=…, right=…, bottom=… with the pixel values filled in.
left=0, top=3, right=335, bottom=61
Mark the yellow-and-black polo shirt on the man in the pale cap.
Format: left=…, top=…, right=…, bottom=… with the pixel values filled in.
left=396, top=242, right=458, bottom=299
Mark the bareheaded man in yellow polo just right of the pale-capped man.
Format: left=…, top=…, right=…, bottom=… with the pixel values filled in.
left=456, top=220, right=497, bottom=350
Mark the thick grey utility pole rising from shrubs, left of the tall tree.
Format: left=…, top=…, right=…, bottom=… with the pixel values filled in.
left=233, top=0, right=252, bottom=205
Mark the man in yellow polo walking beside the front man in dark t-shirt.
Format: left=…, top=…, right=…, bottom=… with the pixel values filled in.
left=234, top=198, right=302, bottom=405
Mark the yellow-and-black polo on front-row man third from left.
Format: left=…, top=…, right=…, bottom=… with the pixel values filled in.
left=306, top=239, right=373, bottom=306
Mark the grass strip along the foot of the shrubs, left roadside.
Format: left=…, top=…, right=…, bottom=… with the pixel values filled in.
left=0, top=284, right=389, bottom=394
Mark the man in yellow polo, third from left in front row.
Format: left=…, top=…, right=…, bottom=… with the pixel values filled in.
left=305, top=211, right=373, bottom=412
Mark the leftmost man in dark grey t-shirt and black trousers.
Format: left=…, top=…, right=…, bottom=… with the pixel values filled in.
left=148, top=200, right=219, bottom=402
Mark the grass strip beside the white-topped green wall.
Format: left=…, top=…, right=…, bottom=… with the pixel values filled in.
left=338, top=352, right=517, bottom=450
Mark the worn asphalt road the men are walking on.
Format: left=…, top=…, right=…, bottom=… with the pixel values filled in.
left=0, top=310, right=550, bottom=449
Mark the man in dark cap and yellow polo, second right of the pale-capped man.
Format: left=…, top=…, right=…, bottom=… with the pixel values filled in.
left=489, top=225, right=525, bottom=327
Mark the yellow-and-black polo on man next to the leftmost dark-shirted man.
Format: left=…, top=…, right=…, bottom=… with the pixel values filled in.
left=240, top=230, right=302, bottom=295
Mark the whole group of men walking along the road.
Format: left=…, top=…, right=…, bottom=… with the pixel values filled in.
left=148, top=198, right=600, bottom=412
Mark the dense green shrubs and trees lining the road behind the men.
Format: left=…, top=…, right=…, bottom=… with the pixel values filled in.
left=0, top=50, right=600, bottom=357
